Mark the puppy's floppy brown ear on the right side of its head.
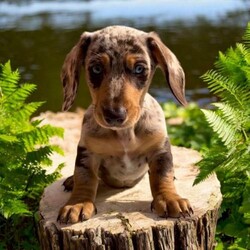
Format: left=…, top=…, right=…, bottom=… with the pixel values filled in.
left=147, top=32, right=187, bottom=106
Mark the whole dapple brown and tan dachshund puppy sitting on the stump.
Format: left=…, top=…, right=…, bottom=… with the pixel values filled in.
left=58, top=26, right=193, bottom=223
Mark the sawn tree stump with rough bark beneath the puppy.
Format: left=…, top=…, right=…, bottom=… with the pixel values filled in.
left=38, top=113, right=222, bottom=250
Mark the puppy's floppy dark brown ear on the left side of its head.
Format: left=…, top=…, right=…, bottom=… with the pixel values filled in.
left=61, top=32, right=91, bottom=111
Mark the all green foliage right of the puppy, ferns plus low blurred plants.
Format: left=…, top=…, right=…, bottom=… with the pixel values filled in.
left=163, top=23, right=250, bottom=249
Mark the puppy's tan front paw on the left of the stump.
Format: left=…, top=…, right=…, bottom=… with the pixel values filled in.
left=57, top=201, right=97, bottom=224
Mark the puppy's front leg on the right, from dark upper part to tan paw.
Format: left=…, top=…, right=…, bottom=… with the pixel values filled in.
left=149, top=139, right=193, bottom=218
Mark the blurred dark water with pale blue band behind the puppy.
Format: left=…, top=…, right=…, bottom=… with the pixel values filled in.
left=0, top=0, right=250, bottom=112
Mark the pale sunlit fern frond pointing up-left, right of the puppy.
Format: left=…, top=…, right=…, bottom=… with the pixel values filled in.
left=201, top=109, right=237, bottom=146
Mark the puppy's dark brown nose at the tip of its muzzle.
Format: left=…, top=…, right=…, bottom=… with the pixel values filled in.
left=103, top=107, right=127, bottom=126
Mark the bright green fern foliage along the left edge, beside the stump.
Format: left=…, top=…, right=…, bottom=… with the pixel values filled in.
left=0, top=62, right=63, bottom=249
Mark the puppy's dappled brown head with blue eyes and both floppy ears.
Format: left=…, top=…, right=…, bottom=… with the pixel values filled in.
left=61, top=26, right=186, bottom=129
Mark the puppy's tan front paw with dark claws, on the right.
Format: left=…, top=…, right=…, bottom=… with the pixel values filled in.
left=151, top=194, right=193, bottom=218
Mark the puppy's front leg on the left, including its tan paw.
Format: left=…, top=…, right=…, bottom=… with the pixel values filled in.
left=57, top=146, right=99, bottom=223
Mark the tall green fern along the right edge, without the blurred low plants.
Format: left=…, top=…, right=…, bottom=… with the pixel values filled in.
left=194, top=23, right=250, bottom=249
